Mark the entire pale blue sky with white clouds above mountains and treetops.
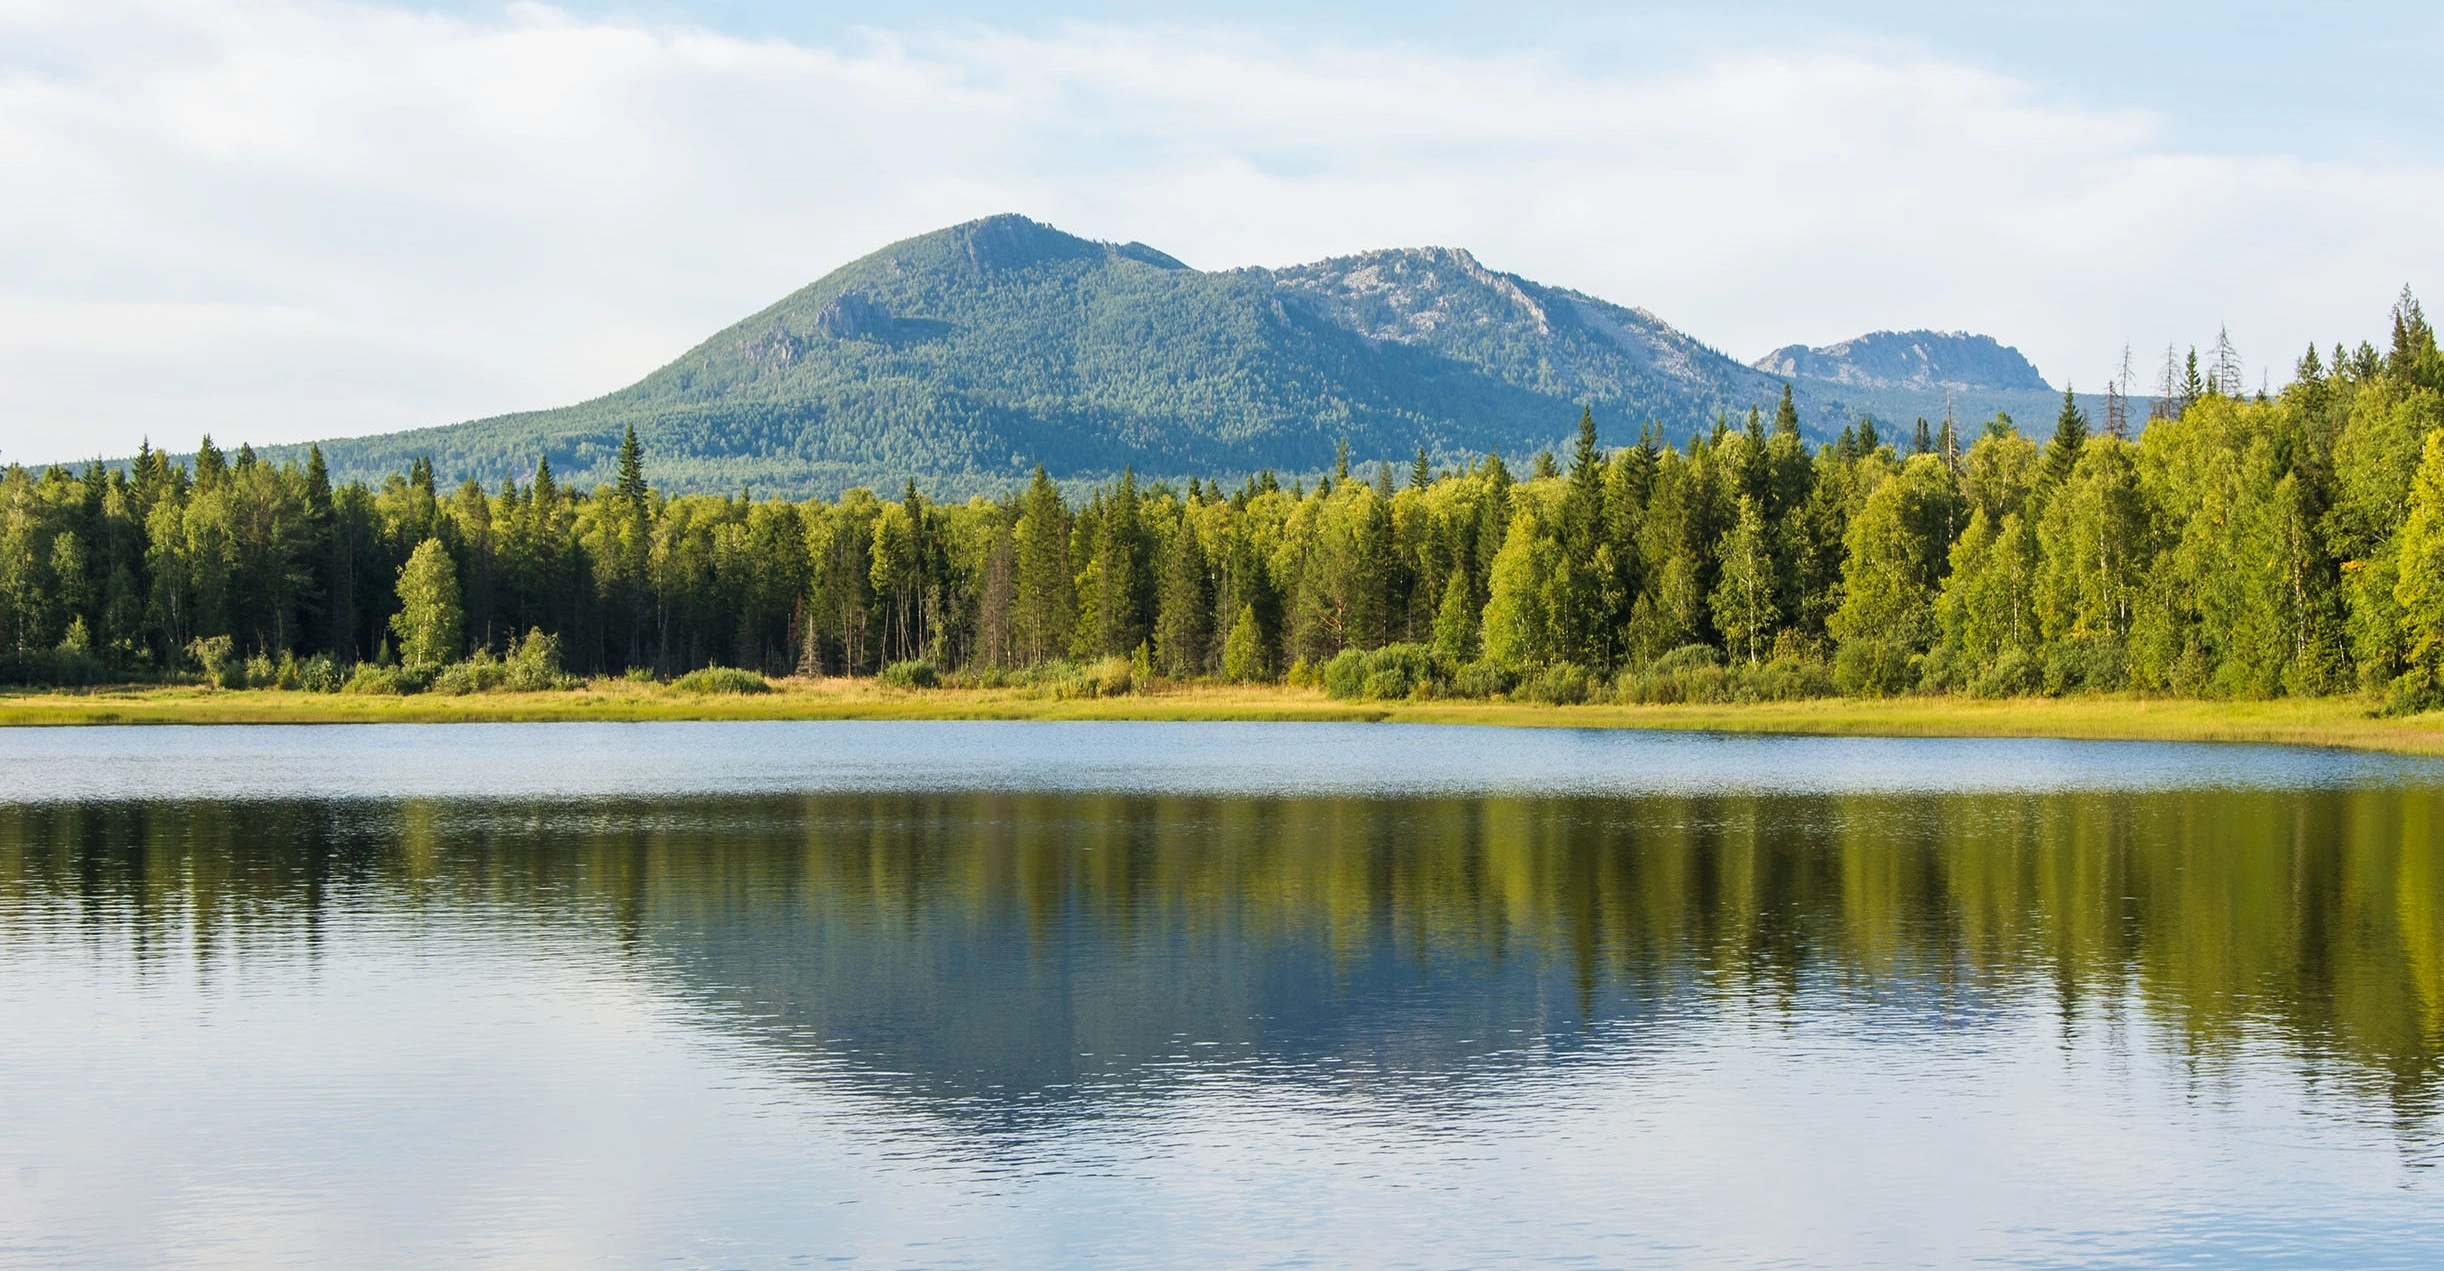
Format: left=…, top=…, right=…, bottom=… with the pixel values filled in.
left=0, top=0, right=2444, bottom=462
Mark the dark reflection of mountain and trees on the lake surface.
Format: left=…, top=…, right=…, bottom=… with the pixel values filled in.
left=0, top=787, right=2444, bottom=1119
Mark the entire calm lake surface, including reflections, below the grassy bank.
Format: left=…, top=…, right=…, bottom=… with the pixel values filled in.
left=0, top=723, right=2444, bottom=1266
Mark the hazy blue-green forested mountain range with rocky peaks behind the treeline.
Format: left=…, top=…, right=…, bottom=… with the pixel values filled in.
left=267, top=215, right=2046, bottom=496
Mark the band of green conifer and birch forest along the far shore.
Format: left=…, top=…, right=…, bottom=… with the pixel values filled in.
left=14, top=293, right=2444, bottom=711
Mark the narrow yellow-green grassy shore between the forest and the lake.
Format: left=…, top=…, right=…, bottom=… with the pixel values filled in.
left=0, top=679, right=2444, bottom=755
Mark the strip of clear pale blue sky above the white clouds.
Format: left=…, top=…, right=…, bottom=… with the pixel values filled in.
left=433, top=0, right=2444, bottom=154
